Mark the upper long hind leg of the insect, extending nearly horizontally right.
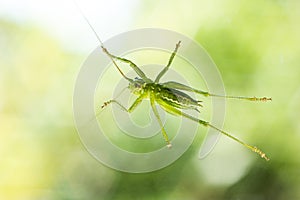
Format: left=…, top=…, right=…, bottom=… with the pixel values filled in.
left=162, top=81, right=272, bottom=101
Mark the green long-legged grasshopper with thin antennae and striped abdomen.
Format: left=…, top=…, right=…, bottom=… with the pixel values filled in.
left=81, top=7, right=272, bottom=161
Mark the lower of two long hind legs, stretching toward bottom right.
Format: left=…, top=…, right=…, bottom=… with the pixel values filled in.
left=160, top=103, right=269, bottom=161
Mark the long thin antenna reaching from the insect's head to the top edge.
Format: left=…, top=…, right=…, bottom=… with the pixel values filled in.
left=73, top=0, right=133, bottom=83
